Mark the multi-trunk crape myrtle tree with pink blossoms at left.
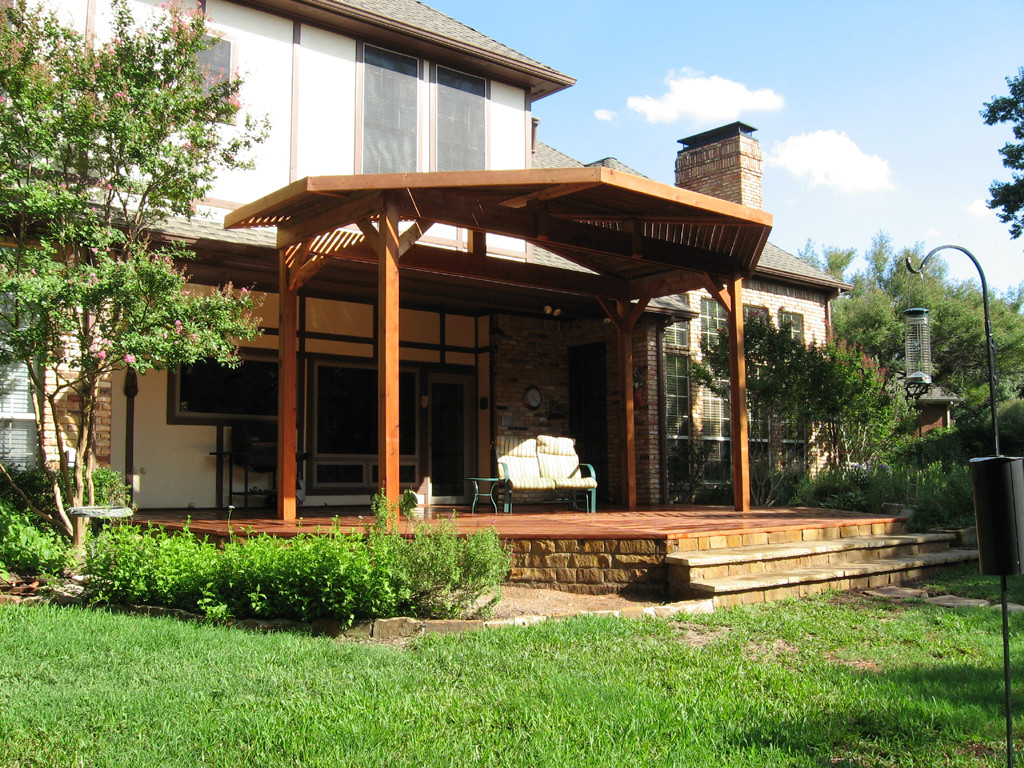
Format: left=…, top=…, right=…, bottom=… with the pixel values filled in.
left=0, top=0, right=266, bottom=535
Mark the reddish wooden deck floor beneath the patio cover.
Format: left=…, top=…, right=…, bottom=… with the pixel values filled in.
left=134, top=505, right=905, bottom=549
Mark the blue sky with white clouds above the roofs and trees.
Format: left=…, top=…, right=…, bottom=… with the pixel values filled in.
left=427, top=0, right=1024, bottom=290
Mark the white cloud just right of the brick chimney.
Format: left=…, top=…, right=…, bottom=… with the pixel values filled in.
left=767, top=131, right=895, bottom=193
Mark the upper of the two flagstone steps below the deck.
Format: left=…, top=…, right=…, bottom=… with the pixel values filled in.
left=666, top=534, right=955, bottom=584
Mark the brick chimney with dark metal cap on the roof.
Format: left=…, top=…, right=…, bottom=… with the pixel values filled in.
left=676, top=123, right=763, bottom=208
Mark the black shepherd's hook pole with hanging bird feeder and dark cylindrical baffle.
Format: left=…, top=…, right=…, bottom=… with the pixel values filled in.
left=903, top=246, right=1024, bottom=768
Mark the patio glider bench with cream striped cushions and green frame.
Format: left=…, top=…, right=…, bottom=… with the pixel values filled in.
left=495, top=434, right=597, bottom=512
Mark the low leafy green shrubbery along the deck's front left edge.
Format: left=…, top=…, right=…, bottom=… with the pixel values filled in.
left=85, top=500, right=510, bottom=624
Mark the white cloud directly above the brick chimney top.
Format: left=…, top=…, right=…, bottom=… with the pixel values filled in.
left=626, top=70, right=785, bottom=123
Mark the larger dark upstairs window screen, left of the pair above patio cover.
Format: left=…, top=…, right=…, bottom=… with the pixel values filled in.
left=362, top=45, right=420, bottom=173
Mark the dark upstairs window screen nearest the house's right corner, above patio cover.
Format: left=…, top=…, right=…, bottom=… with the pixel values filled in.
left=436, top=67, right=479, bottom=171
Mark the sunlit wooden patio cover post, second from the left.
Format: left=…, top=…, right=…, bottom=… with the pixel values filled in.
left=377, top=193, right=400, bottom=503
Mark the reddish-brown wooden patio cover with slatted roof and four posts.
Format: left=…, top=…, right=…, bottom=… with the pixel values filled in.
left=224, top=167, right=772, bottom=519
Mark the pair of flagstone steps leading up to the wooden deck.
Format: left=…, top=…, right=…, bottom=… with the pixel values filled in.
left=666, top=534, right=978, bottom=606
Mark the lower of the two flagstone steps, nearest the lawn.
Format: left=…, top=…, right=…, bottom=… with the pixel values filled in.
left=687, top=549, right=978, bottom=606
